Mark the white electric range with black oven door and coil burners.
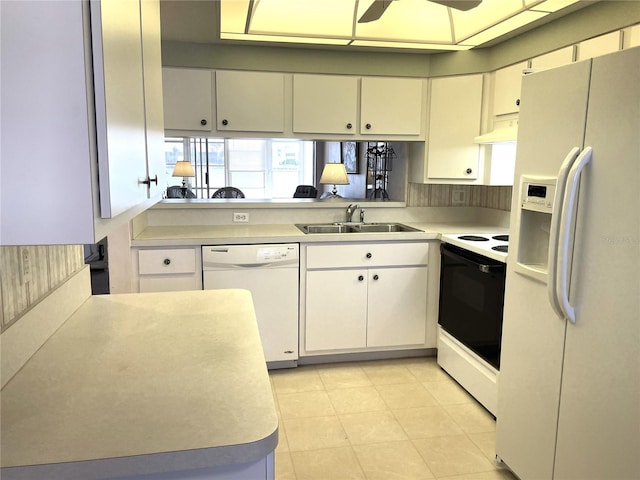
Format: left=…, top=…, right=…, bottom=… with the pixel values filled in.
left=437, top=232, right=509, bottom=416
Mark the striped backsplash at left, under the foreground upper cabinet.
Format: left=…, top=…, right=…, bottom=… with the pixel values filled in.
left=0, top=245, right=84, bottom=331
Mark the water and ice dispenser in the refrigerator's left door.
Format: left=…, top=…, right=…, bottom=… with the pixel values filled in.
left=514, top=175, right=557, bottom=283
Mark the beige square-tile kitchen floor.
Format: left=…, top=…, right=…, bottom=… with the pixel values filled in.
left=270, top=358, right=515, bottom=480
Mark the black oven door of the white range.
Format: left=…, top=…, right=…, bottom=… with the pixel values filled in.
left=438, top=243, right=506, bottom=369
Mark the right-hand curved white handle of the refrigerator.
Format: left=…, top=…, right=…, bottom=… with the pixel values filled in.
left=557, top=147, right=593, bottom=323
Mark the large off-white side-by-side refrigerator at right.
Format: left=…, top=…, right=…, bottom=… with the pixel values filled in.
left=496, top=48, right=640, bottom=480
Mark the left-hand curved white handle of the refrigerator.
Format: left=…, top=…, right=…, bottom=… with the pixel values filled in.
left=547, top=147, right=580, bottom=319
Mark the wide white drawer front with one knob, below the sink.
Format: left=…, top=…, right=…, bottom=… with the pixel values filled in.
left=307, top=242, right=429, bottom=268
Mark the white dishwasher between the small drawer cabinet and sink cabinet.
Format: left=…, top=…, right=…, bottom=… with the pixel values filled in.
left=202, top=243, right=300, bottom=368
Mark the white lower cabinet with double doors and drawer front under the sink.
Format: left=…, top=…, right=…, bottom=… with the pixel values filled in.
left=301, top=242, right=428, bottom=355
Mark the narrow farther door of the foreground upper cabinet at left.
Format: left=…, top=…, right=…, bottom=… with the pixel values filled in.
left=140, top=0, right=166, bottom=198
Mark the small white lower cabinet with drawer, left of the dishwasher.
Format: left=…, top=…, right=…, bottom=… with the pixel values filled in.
left=138, top=248, right=202, bottom=293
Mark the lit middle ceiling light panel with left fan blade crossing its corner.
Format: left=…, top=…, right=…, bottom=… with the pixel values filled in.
left=346, top=0, right=452, bottom=43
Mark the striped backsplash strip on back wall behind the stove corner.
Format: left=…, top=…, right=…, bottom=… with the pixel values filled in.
left=407, top=183, right=513, bottom=211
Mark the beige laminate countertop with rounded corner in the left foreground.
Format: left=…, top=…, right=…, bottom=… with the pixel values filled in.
left=0, top=290, right=278, bottom=480
